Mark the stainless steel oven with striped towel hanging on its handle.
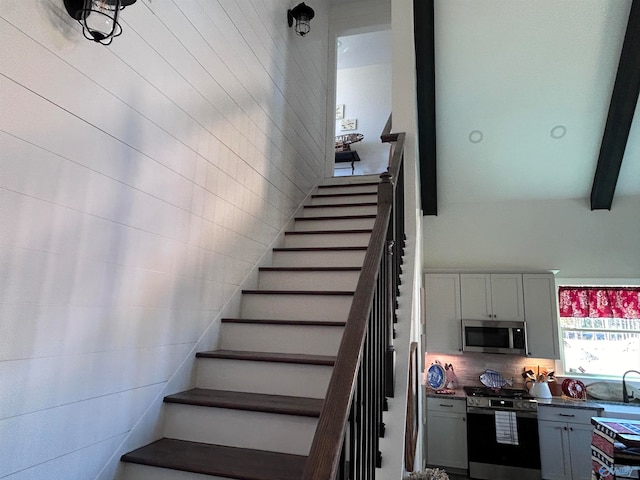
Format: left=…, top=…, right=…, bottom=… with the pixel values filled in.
left=464, top=387, right=541, bottom=480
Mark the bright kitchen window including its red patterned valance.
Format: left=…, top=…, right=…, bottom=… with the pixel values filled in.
left=558, top=286, right=640, bottom=377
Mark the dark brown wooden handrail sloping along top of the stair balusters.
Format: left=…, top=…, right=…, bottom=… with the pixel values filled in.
left=302, top=125, right=405, bottom=480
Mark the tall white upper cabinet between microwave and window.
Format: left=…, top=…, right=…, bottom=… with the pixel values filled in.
left=522, top=273, right=560, bottom=359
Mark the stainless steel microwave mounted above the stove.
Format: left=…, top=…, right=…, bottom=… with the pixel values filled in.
left=462, top=320, right=527, bottom=355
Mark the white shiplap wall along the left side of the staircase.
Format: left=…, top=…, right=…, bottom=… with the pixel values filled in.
left=0, top=0, right=328, bottom=480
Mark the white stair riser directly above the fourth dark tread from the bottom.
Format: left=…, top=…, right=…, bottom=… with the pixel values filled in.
left=241, top=293, right=353, bottom=322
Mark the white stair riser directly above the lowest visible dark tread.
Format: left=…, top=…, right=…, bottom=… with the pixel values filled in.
left=164, top=404, right=318, bottom=455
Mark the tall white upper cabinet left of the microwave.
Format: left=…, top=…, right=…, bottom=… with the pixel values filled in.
left=424, top=273, right=462, bottom=354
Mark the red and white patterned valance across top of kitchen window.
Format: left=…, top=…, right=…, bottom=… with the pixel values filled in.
left=558, top=287, right=640, bottom=319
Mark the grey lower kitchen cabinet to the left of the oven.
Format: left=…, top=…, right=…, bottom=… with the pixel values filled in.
left=426, top=397, right=468, bottom=470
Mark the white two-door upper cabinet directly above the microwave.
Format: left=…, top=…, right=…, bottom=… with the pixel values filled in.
left=460, top=273, right=524, bottom=322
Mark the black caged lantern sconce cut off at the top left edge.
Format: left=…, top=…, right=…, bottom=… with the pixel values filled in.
left=64, top=0, right=136, bottom=45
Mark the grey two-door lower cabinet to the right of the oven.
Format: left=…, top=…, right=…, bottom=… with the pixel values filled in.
left=538, top=406, right=600, bottom=480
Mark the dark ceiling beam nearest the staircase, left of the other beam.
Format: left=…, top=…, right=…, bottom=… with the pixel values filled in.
left=413, top=0, right=438, bottom=215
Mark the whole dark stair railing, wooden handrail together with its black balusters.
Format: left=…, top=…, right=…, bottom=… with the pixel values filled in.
left=302, top=117, right=405, bottom=480
